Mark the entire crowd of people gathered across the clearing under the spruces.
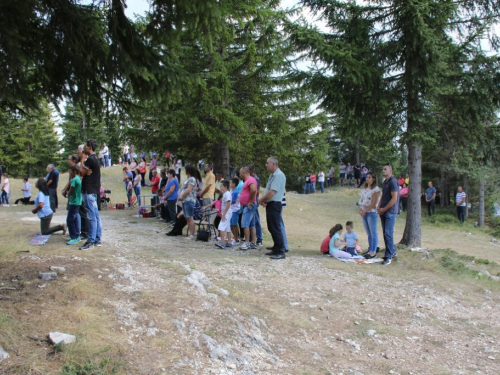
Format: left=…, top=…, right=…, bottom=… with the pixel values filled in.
left=0, top=139, right=472, bottom=265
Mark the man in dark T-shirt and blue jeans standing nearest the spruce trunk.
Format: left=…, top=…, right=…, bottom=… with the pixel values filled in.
left=377, top=164, right=399, bottom=266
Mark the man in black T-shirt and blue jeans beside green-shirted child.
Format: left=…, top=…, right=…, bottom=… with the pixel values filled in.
left=80, top=139, right=101, bottom=250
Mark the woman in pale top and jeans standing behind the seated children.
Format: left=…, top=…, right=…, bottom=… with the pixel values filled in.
left=358, top=172, right=380, bottom=259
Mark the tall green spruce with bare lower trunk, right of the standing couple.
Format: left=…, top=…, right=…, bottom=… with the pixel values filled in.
left=290, top=0, right=500, bottom=246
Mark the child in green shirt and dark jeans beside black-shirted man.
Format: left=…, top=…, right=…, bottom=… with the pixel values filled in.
left=66, top=165, right=82, bottom=245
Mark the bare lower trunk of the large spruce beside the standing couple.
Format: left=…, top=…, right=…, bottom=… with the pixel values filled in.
left=400, top=142, right=422, bottom=247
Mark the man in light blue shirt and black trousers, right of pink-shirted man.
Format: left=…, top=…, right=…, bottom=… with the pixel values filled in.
left=259, top=157, right=286, bottom=259
